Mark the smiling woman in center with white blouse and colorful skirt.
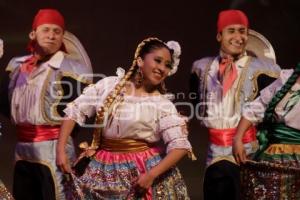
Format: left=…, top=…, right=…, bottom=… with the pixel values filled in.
left=57, top=38, right=192, bottom=199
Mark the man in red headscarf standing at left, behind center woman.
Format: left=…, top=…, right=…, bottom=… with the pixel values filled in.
left=0, top=9, right=92, bottom=200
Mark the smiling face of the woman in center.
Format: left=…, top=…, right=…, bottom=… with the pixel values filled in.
left=137, top=47, right=172, bottom=86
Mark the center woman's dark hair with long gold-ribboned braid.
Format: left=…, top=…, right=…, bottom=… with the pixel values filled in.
left=91, top=37, right=173, bottom=148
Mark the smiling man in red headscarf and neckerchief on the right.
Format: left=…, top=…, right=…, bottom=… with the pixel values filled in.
left=191, top=10, right=280, bottom=200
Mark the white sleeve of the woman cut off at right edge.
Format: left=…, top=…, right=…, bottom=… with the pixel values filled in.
left=243, top=70, right=293, bottom=124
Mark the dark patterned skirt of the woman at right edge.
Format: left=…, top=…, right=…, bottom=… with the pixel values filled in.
left=241, top=144, right=300, bottom=200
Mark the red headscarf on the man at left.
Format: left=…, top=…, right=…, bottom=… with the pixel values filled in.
left=32, top=9, right=65, bottom=30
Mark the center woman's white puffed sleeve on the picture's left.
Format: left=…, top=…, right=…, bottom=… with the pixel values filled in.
left=64, top=77, right=116, bottom=125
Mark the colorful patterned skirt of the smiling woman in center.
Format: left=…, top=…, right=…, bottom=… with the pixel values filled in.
left=66, top=147, right=189, bottom=200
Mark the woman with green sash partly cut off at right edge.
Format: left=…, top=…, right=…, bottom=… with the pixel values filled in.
left=233, top=64, right=300, bottom=199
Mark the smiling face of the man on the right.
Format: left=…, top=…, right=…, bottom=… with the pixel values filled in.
left=217, top=24, right=248, bottom=57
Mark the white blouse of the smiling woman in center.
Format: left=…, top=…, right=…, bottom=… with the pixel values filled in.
left=64, top=73, right=191, bottom=152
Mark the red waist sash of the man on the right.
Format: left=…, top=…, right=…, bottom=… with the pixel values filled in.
left=208, top=126, right=256, bottom=147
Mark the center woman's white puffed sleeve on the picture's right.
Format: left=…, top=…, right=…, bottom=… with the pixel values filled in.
left=158, top=102, right=192, bottom=159
